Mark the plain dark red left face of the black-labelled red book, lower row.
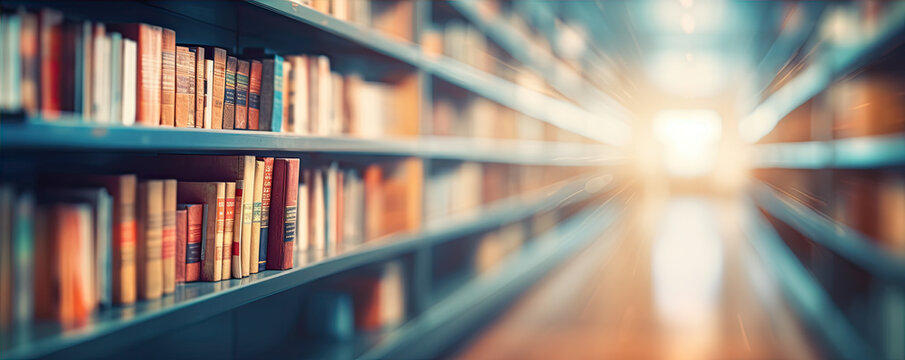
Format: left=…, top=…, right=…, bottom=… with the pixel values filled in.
left=266, top=159, right=288, bottom=270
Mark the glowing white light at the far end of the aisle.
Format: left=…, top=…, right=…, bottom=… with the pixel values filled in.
left=653, top=110, right=721, bottom=177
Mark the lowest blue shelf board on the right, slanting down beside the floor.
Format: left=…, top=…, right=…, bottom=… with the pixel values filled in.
left=742, top=200, right=880, bottom=359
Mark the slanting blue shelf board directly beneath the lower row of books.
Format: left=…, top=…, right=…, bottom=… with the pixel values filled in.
left=0, top=173, right=603, bottom=358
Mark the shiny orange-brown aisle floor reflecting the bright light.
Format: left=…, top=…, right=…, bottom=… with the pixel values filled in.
left=457, top=197, right=816, bottom=359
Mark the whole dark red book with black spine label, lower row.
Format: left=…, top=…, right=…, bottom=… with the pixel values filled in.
left=267, top=159, right=299, bottom=270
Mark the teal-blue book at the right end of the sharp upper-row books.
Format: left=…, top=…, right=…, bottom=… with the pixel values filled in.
left=258, top=55, right=283, bottom=132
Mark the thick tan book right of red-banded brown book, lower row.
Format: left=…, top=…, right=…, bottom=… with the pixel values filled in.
left=135, top=180, right=163, bottom=299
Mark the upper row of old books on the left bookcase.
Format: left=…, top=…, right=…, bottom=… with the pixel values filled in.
left=0, top=9, right=406, bottom=137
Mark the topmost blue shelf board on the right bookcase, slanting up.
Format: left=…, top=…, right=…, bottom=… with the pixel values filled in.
left=739, top=1, right=905, bottom=143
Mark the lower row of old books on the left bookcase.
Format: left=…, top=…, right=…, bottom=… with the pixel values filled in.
left=0, top=155, right=422, bottom=326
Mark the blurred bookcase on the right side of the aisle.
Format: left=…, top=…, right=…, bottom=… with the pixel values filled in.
left=738, top=2, right=905, bottom=357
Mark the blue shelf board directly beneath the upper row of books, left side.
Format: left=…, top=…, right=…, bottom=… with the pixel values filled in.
left=0, top=119, right=622, bottom=166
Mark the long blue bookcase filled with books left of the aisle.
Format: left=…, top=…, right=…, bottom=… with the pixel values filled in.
left=0, top=0, right=630, bottom=358
